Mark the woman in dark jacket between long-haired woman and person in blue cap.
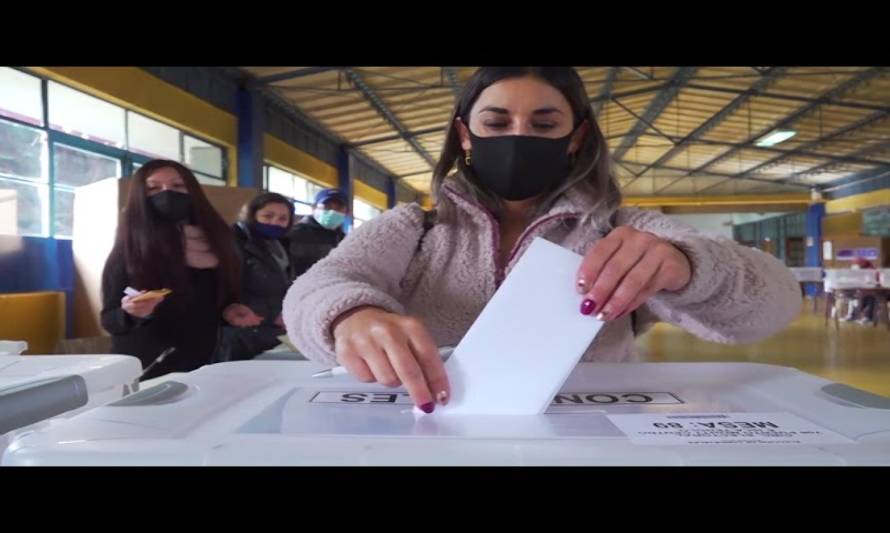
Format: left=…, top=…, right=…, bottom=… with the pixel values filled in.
left=218, top=192, right=294, bottom=361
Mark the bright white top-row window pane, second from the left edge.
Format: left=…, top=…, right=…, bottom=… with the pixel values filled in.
left=49, top=81, right=125, bottom=148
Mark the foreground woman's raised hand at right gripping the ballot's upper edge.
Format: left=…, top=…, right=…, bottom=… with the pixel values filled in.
left=577, top=226, right=692, bottom=320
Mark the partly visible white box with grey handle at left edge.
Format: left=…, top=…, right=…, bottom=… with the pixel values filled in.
left=0, top=355, right=142, bottom=451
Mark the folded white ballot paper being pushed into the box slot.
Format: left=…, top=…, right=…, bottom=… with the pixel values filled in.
left=436, top=238, right=603, bottom=415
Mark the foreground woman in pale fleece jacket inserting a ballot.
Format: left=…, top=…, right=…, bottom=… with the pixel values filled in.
left=284, top=67, right=801, bottom=412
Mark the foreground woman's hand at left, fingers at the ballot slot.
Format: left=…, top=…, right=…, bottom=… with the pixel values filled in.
left=331, top=307, right=451, bottom=413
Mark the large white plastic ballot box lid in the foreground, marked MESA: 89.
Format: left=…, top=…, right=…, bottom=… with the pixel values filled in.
left=2, top=361, right=890, bottom=465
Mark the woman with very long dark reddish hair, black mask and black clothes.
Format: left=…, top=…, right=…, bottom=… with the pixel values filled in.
left=101, top=160, right=261, bottom=379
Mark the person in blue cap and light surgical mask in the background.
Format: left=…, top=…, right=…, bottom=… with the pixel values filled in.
left=288, top=189, right=349, bottom=276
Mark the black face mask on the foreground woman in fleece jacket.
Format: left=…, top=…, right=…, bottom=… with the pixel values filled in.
left=470, top=132, right=572, bottom=201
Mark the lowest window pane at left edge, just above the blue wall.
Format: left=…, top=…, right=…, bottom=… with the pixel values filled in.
left=0, top=178, right=49, bottom=236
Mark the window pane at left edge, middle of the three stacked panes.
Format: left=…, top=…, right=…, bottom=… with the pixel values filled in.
left=0, top=120, right=49, bottom=182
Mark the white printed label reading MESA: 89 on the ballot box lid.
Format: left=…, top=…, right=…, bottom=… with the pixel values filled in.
left=606, top=413, right=855, bottom=446
